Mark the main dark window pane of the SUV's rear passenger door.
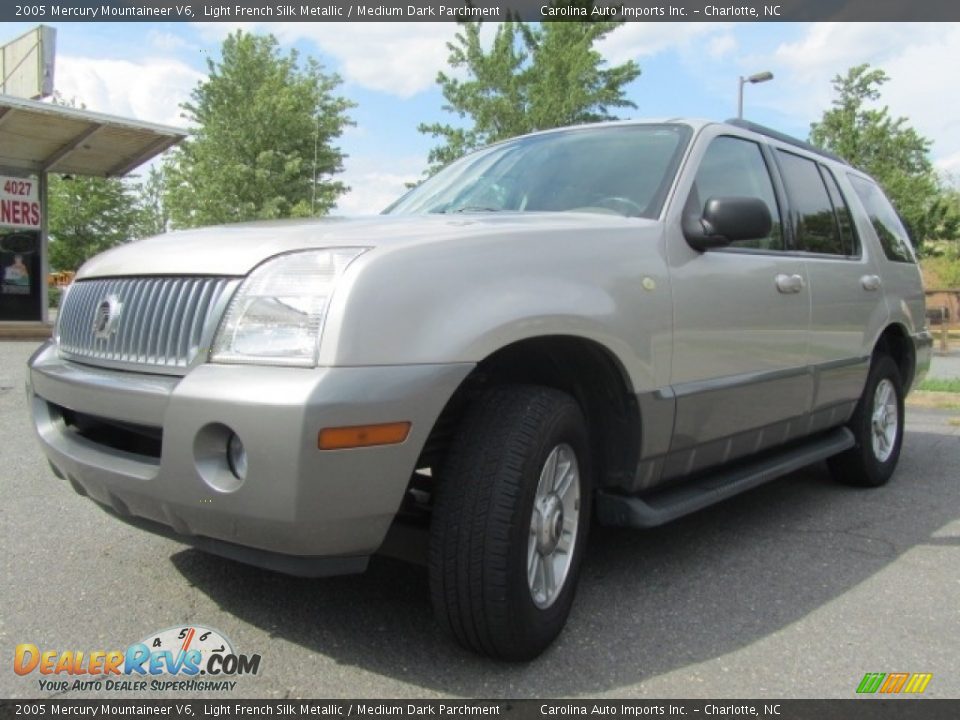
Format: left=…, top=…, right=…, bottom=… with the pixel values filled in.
left=777, top=150, right=846, bottom=255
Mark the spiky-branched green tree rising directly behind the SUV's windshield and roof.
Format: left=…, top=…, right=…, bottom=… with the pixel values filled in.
left=418, top=20, right=640, bottom=173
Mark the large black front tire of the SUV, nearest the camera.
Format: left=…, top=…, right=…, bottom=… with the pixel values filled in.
left=429, top=385, right=591, bottom=660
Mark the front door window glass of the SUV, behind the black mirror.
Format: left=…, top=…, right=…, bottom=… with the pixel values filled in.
left=685, top=136, right=783, bottom=250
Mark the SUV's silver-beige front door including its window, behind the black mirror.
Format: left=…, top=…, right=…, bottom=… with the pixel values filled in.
left=663, top=128, right=813, bottom=479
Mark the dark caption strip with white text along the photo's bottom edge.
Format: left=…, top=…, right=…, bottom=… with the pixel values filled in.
left=0, top=696, right=960, bottom=720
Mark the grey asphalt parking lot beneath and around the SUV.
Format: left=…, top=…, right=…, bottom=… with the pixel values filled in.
left=0, top=342, right=960, bottom=698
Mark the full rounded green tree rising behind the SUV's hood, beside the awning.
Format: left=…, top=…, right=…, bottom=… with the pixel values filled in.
left=165, top=31, right=353, bottom=227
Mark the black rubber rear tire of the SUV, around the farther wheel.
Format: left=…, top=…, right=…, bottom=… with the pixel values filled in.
left=828, top=354, right=904, bottom=487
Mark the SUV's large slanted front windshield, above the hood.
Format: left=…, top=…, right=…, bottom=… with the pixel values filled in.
left=384, top=125, right=691, bottom=218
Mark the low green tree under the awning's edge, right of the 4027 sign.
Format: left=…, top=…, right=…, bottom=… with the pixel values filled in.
left=47, top=175, right=141, bottom=270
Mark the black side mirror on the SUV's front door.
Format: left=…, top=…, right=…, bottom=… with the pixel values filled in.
left=683, top=197, right=773, bottom=252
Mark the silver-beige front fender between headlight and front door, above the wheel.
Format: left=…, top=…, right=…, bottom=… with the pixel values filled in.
left=320, top=217, right=671, bottom=391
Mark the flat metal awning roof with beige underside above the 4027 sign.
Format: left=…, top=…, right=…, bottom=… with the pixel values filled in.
left=0, top=95, right=187, bottom=177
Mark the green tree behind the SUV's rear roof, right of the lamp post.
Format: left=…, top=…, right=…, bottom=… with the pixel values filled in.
left=810, top=64, right=955, bottom=250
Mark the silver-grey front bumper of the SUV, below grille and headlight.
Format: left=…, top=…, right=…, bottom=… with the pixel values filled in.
left=29, top=343, right=473, bottom=575
